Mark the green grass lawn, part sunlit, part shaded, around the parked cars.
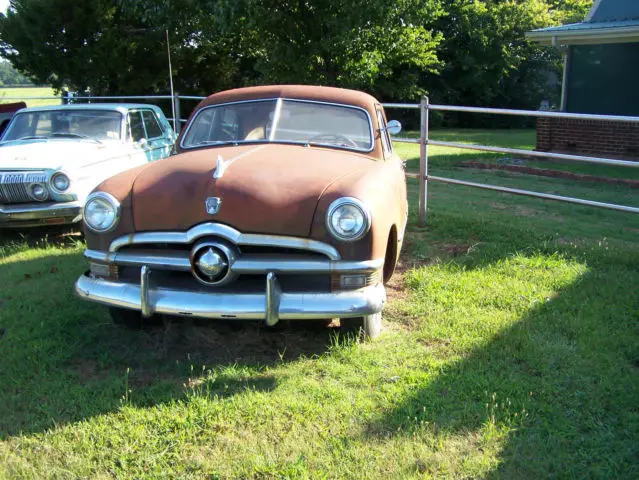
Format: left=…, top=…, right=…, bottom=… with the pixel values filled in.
left=0, top=132, right=639, bottom=479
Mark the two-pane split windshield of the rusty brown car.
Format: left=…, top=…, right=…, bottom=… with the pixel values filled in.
left=182, top=100, right=373, bottom=151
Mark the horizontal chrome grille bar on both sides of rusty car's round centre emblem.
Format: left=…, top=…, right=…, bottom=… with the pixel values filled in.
left=84, top=250, right=384, bottom=275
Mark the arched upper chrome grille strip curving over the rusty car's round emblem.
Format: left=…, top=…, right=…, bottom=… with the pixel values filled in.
left=109, top=222, right=341, bottom=260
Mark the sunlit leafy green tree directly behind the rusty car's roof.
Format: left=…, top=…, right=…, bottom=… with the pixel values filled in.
left=216, top=0, right=442, bottom=99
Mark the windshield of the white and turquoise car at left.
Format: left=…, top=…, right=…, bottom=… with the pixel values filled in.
left=2, top=109, right=122, bottom=141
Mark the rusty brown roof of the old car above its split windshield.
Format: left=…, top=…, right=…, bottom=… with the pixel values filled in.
left=199, top=85, right=379, bottom=110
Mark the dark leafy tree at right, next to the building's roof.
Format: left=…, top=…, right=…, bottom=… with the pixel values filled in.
left=423, top=0, right=592, bottom=122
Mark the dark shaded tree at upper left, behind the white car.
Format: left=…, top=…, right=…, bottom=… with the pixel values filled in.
left=0, top=0, right=250, bottom=95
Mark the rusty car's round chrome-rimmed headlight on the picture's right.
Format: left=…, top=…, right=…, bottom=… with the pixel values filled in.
left=326, top=197, right=371, bottom=242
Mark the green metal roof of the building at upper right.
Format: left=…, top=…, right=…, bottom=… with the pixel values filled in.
left=526, top=0, right=639, bottom=45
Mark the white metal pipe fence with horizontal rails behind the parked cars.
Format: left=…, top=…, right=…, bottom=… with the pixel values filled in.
left=0, top=93, right=639, bottom=226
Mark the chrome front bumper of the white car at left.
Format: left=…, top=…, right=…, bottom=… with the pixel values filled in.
left=0, top=202, right=82, bottom=227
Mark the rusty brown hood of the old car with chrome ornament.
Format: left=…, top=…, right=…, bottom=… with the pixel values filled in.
left=132, top=144, right=377, bottom=237
